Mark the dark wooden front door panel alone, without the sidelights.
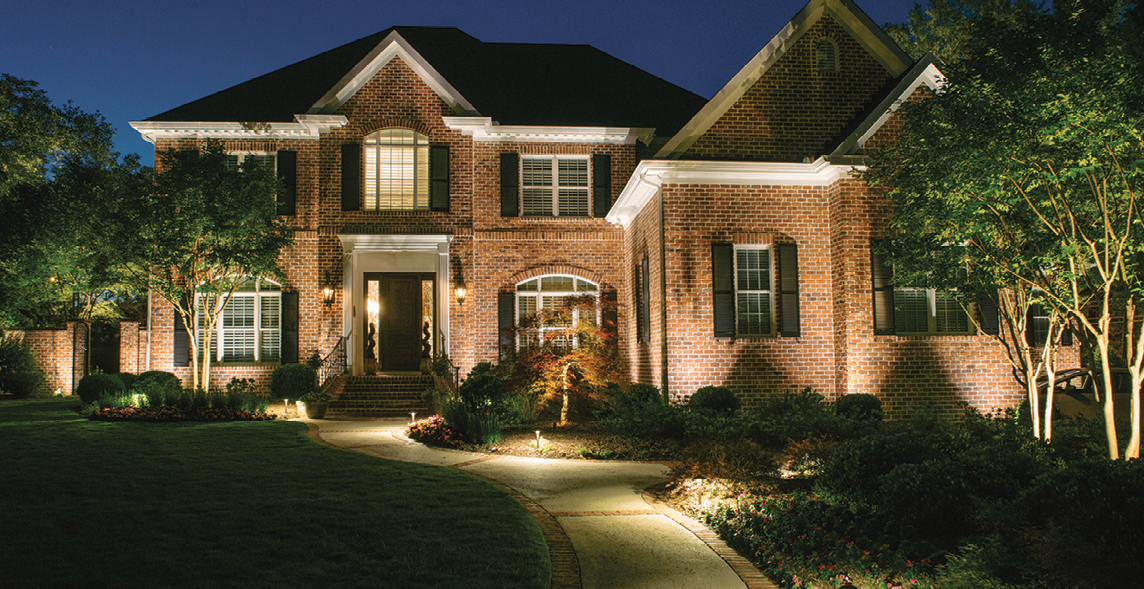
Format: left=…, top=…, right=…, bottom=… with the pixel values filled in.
left=378, top=274, right=421, bottom=372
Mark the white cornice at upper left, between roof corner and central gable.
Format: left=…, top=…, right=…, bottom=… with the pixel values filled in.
left=128, top=114, right=347, bottom=144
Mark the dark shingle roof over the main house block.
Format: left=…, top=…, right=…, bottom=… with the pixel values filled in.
left=148, top=26, right=706, bottom=135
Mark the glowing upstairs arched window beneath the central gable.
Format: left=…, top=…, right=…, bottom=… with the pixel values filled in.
left=363, top=129, right=429, bottom=210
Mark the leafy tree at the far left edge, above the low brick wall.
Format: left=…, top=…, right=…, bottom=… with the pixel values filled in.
left=0, top=74, right=125, bottom=326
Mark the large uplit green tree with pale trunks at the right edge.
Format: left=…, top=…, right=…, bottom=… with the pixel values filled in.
left=867, top=0, right=1144, bottom=459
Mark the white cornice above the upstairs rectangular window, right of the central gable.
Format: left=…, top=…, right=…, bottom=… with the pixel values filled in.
left=444, top=117, right=656, bottom=145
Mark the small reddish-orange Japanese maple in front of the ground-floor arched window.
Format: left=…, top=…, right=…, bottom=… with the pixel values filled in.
left=509, top=295, right=622, bottom=424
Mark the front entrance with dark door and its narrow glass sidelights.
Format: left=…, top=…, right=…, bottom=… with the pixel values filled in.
left=363, top=273, right=432, bottom=372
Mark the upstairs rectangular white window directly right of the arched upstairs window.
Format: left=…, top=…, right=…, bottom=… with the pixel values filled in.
left=521, top=156, right=588, bottom=217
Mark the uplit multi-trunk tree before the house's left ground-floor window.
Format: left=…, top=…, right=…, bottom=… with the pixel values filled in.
left=120, top=143, right=293, bottom=389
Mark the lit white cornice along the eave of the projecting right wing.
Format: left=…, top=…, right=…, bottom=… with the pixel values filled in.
left=606, top=158, right=863, bottom=226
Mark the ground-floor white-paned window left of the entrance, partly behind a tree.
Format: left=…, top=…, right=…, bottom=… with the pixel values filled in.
left=197, top=278, right=281, bottom=363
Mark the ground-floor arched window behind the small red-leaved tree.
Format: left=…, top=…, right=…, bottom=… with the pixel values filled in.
left=516, top=276, right=599, bottom=348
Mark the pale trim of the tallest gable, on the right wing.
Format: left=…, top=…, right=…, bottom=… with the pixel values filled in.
left=656, top=0, right=912, bottom=159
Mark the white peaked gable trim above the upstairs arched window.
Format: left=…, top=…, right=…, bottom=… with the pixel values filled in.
left=310, top=31, right=479, bottom=116
